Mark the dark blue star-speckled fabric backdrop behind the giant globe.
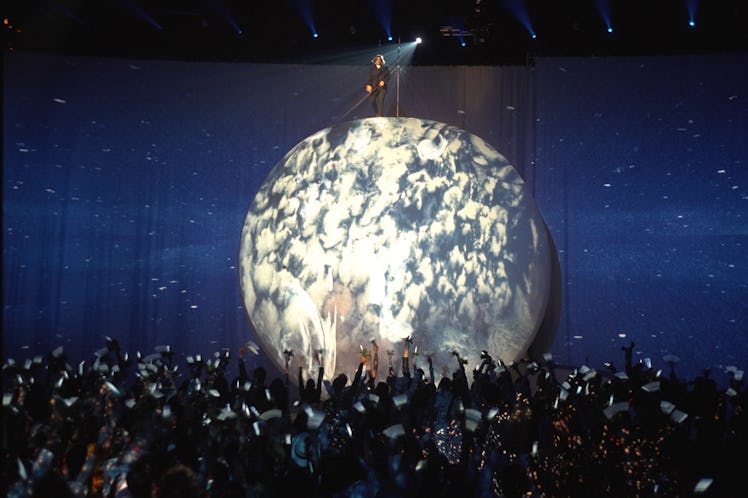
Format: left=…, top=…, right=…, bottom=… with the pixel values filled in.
left=2, top=54, right=748, bottom=380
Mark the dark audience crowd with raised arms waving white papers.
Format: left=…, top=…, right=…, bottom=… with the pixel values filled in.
left=2, top=339, right=748, bottom=498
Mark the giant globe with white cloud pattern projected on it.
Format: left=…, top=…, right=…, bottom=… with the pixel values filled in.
left=239, top=118, right=552, bottom=377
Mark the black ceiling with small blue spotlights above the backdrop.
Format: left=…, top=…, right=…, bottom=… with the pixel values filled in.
left=3, top=0, right=748, bottom=65
